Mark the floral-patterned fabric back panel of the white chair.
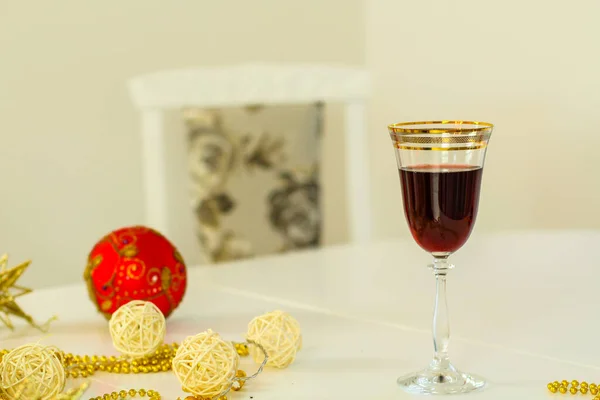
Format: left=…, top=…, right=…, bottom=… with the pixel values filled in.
left=184, top=104, right=323, bottom=262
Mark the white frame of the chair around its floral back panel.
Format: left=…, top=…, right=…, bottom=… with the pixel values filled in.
left=129, top=64, right=371, bottom=261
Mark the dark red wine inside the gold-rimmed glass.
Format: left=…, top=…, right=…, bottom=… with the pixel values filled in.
left=400, top=165, right=483, bottom=254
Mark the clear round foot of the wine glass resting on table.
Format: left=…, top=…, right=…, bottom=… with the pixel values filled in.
left=398, top=363, right=485, bottom=394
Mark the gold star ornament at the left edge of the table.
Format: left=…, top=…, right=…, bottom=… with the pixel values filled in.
left=0, top=254, right=56, bottom=332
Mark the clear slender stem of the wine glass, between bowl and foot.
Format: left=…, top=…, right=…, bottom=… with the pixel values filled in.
left=431, top=256, right=454, bottom=369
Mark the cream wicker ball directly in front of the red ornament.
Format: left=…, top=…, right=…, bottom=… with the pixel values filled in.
left=109, top=300, right=166, bottom=358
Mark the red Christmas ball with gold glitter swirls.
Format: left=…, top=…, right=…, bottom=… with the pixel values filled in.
left=84, top=226, right=187, bottom=318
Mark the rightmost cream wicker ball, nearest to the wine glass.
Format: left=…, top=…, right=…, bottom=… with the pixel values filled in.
left=246, top=310, right=302, bottom=368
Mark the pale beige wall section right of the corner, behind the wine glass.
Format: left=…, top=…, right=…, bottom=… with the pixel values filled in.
left=366, top=0, right=600, bottom=241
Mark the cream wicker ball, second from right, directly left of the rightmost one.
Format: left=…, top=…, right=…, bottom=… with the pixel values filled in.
left=173, top=329, right=239, bottom=398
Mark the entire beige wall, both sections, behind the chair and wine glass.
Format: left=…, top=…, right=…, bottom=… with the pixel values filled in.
left=5, top=0, right=600, bottom=287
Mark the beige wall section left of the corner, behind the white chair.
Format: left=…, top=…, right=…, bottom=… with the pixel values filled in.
left=0, top=0, right=365, bottom=287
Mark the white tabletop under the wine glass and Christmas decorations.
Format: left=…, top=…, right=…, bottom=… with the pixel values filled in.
left=2, top=231, right=600, bottom=400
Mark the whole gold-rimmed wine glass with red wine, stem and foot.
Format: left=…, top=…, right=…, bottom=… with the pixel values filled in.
left=388, top=121, right=493, bottom=394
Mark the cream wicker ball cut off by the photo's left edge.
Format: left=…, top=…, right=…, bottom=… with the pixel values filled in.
left=0, top=343, right=65, bottom=400
